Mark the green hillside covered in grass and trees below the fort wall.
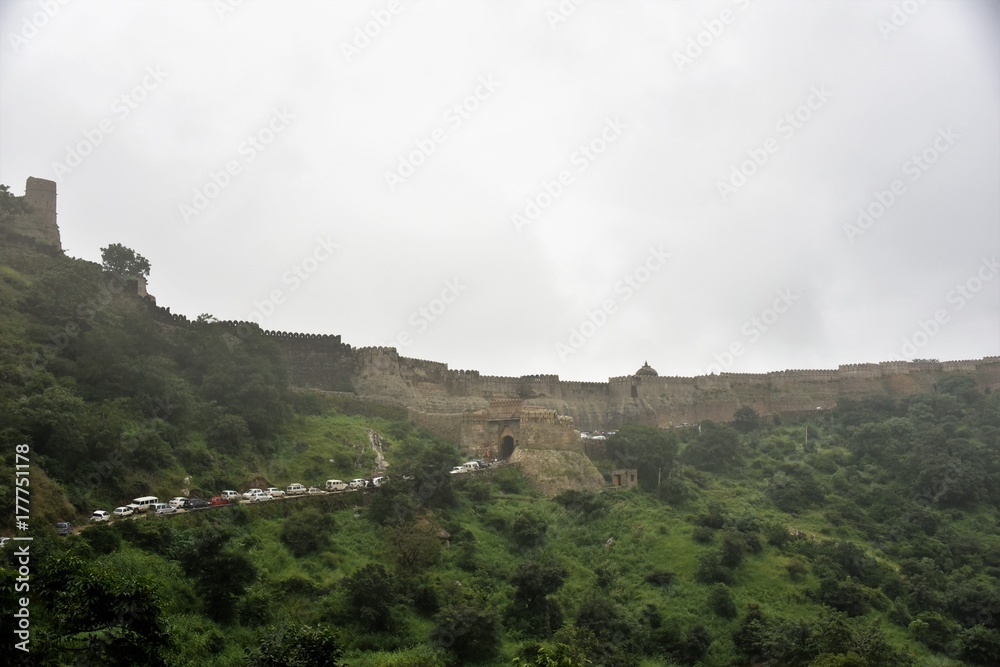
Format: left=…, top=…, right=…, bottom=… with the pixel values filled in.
left=0, top=237, right=1000, bottom=667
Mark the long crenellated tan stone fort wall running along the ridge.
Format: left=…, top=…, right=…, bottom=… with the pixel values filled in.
left=125, top=294, right=1000, bottom=436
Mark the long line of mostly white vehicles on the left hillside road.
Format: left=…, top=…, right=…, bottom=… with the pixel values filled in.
left=90, top=475, right=389, bottom=523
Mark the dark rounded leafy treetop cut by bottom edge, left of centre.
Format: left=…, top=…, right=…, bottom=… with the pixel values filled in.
left=247, top=625, right=344, bottom=667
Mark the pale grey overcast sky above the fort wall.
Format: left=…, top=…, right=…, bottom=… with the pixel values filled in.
left=0, top=0, right=1000, bottom=381
